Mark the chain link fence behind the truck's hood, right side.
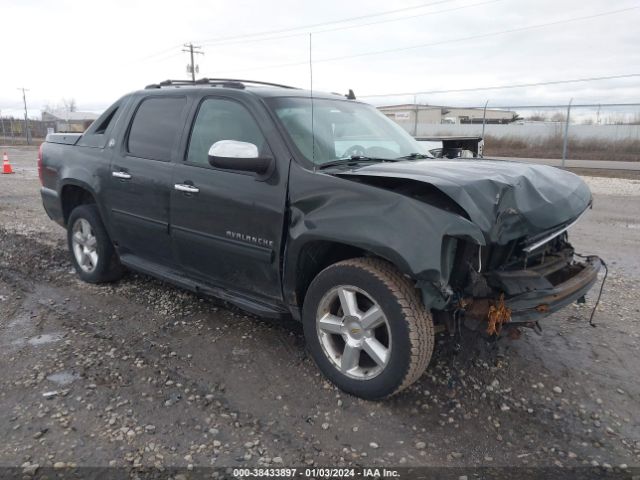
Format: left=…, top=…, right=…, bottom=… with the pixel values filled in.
left=383, top=101, right=640, bottom=161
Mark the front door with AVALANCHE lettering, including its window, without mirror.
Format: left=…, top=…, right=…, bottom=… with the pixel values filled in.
left=171, top=98, right=287, bottom=300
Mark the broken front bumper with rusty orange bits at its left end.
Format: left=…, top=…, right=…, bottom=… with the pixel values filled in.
left=464, top=254, right=602, bottom=331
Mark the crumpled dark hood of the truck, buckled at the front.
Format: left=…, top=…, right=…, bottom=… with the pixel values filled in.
left=339, top=159, right=591, bottom=244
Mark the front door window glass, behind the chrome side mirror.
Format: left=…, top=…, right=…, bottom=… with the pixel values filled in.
left=187, top=98, right=268, bottom=165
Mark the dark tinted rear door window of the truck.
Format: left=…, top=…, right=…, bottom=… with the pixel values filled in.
left=127, top=97, right=187, bottom=162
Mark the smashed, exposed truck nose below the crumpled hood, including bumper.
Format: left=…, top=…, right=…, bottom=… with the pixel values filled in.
left=451, top=231, right=602, bottom=335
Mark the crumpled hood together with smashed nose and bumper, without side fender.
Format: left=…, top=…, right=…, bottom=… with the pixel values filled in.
left=336, top=160, right=602, bottom=334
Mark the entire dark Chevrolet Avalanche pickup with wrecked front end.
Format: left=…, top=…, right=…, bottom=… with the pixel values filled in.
left=38, top=79, right=602, bottom=399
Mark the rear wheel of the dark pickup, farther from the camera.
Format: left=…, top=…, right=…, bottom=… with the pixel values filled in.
left=67, top=204, right=123, bottom=283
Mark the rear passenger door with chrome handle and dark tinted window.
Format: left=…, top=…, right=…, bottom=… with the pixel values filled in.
left=106, top=95, right=188, bottom=265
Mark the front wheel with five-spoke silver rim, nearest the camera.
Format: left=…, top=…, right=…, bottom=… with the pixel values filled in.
left=302, top=258, right=434, bottom=400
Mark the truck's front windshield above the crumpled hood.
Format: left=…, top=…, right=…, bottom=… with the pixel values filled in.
left=269, top=98, right=431, bottom=165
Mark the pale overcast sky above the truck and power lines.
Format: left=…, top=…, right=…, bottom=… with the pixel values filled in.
left=0, top=0, right=640, bottom=116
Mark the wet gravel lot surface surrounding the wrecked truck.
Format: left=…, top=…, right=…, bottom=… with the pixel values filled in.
left=0, top=148, right=640, bottom=478
